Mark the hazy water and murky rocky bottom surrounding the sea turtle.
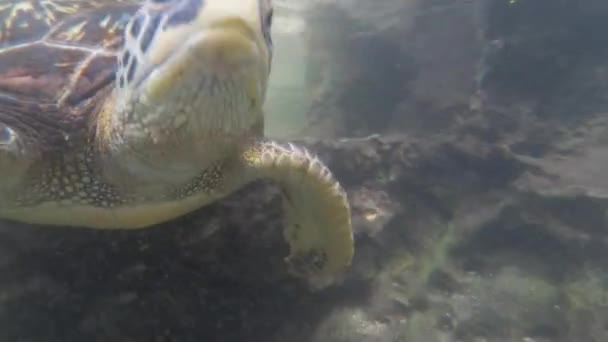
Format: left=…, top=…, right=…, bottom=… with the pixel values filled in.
left=0, top=0, right=608, bottom=342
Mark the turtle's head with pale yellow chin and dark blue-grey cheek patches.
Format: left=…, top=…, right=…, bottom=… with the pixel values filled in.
left=98, top=0, right=273, bottom=184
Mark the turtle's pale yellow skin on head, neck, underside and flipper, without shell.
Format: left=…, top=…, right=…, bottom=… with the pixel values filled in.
left=0, top=0, right=354, bottom=287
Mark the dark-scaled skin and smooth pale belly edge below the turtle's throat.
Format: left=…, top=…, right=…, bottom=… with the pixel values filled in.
left=0, top=148, right=237, bottom=229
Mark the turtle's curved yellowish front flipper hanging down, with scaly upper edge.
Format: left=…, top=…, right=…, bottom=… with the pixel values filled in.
left=243, top=141, right=354, bottom=288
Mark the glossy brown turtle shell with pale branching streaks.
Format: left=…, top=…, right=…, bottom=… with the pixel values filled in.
left=0, top=0, right=142, bottom=154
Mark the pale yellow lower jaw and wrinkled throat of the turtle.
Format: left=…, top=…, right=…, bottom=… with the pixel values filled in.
left=126, top=19, right=268, bottom=144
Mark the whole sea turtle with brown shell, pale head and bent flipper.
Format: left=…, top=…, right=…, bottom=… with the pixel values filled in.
left=0, top=0, right=354, bottom=286
